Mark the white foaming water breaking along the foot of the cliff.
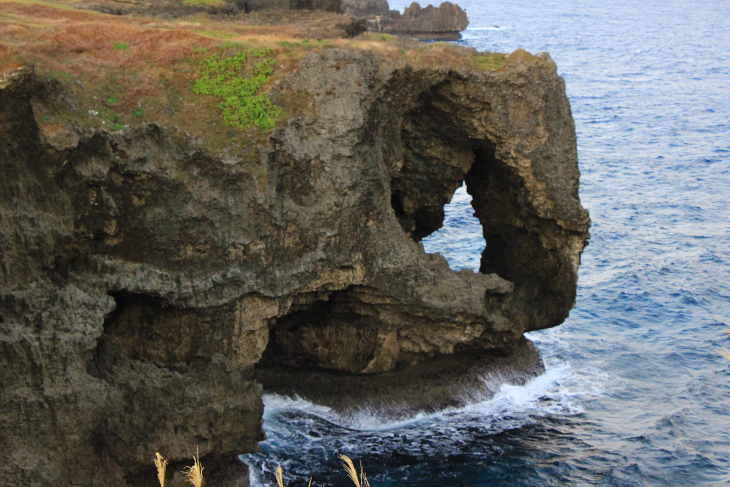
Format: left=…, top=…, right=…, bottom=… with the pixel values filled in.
left=241, top=340, right=601, bottom=487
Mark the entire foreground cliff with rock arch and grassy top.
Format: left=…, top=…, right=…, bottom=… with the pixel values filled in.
left=0, top=0, right=590, bottom=487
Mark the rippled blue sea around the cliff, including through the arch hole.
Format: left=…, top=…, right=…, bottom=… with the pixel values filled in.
left=240, top=0, right=730, bottom=487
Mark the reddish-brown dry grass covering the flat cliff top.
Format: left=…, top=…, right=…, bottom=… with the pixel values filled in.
left=0, top=0, right=536, bottom=152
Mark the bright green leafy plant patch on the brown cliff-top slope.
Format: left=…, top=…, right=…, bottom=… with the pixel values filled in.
left=193, top=49, right=280, bottom=131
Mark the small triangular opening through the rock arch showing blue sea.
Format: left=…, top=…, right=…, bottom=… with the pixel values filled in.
left=422, top=185, right=486, bottom=271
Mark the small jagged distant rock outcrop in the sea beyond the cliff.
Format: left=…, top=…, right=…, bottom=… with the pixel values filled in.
left=368, top=2, right=469, bottom=40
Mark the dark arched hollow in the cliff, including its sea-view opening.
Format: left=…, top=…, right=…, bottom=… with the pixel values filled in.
left=391, top=97, right=506, bottom=275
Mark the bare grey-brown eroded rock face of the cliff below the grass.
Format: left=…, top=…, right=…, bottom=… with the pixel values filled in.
left=0, top=49, right=589, bottom=486
